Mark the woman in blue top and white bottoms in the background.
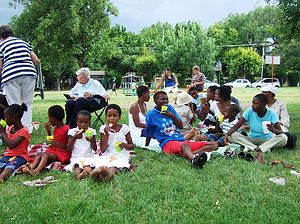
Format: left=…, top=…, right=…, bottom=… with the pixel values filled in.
left=154, top=67, right=178, bottom=95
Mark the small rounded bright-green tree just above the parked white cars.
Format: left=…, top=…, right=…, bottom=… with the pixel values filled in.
left=224, top=47, right=262, bottom=80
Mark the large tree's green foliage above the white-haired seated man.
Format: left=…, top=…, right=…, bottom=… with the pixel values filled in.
left=12, top=0, right=117, bottom=89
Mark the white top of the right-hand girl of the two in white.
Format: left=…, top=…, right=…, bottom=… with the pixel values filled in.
left=100, top=124, right=130, bottom=154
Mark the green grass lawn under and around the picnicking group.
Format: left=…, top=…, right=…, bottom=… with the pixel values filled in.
left=0, top=88, right=300, bottom=223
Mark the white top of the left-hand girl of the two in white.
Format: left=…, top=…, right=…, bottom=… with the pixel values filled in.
left=68, top=127, right=96, bottom=158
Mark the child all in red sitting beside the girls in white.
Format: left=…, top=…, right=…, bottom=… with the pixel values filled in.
left=22, top=105, right=71, bottom=175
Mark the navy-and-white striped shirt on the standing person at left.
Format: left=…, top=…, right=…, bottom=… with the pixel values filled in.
left=0, top=37, right=37, bottom=86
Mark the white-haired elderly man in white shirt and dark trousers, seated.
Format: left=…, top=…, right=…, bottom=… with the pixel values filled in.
left=66, top=68, right=109, bottom=128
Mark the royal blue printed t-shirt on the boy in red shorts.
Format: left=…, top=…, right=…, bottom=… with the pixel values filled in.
left=146, top=105, right=185, bottom=148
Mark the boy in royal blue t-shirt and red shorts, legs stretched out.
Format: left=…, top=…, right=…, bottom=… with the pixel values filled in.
left=146, top=91, right=218, bottom=169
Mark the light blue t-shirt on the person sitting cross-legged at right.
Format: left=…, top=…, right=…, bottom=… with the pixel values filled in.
left=243, top=108, right=279, bottom=139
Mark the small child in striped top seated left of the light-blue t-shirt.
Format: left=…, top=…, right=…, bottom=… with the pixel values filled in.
left=208, top=104, right=240, bottom=146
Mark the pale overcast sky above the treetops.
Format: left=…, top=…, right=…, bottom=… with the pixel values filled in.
left=0, top=0, right=266, bottom=33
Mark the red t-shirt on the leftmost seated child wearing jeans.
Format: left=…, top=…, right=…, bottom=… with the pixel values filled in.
left=4, top=125, right=30, bottom=161
